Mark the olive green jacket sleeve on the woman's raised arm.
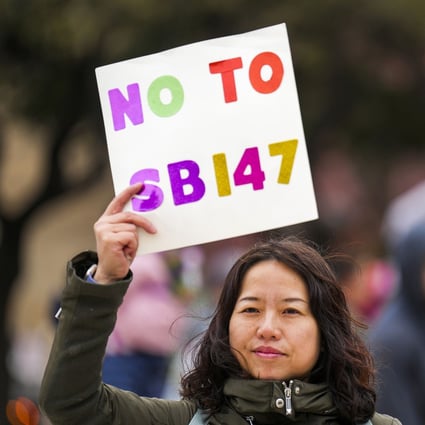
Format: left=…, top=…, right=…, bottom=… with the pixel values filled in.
left=39, top=252, right=196, bottom=425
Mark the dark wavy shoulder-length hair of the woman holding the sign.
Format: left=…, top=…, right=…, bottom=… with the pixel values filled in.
left=180, top=236, right=376, bottom=424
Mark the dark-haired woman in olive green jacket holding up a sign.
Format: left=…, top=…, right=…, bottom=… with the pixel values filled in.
left=40, top=185, right=400, bottom=425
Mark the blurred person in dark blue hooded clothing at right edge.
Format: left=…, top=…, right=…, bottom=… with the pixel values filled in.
left=369, top=221, right=425, bottom=425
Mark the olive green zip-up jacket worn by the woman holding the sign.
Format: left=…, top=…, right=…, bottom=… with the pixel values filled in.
left=39, top=252, right=400, bottom=425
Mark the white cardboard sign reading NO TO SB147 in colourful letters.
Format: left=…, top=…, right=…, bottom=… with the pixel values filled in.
left=96, top=24, right=318, bottom=253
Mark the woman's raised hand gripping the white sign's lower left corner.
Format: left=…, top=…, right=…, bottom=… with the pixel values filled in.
left=93, top=183, right=156, bottom=284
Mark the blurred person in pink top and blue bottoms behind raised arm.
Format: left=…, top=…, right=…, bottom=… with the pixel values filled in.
left=102, top=250, right=185, bottom=397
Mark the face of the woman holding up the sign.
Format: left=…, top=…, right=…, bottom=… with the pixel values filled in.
left=229, top=260, right=320, bottom=380
